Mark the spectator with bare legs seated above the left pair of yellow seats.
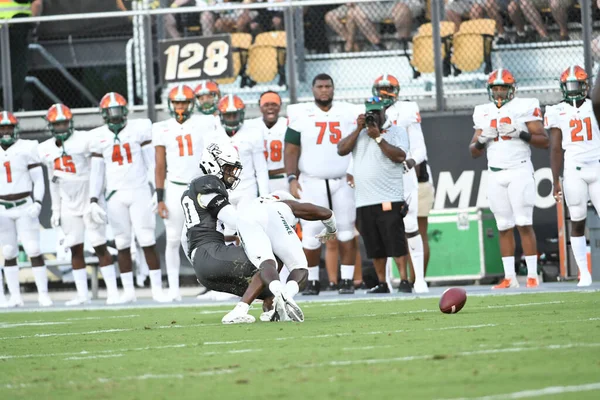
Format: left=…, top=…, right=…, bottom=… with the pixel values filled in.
left=197, top=0, right=258, bottom=36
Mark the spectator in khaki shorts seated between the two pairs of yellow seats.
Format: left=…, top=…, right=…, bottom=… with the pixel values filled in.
left=325, top=1, right=393, bottom=52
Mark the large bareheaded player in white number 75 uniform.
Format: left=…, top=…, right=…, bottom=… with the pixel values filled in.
left=284, top=74, right=359, bottom=295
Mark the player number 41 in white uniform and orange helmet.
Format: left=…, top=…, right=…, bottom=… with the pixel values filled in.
left=88, top=92, right=171, bottom=303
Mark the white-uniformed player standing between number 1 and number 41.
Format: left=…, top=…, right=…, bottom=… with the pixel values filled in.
left=38, top=104, right=119, bottom=306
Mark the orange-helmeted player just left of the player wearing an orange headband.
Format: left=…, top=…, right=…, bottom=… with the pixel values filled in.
left=218, top=94, right=269, bottom=206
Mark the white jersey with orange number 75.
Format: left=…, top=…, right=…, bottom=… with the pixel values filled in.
left=285, top=102, right=364, bottom=179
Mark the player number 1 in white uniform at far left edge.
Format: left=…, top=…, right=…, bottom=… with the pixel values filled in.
left=0, top=111, right=52, bottom=307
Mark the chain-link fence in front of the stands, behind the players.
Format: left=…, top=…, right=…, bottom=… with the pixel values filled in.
left=0, top=0, right=600, bottom=120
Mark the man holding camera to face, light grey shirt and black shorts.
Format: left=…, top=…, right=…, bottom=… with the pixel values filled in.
left=338, top=97, right=409, bottom=293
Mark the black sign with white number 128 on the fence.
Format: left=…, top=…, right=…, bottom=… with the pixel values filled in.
left=159, top=35, right=233, bottom=82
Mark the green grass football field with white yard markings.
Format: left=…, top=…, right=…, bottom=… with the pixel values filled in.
left=0, top=293, right=600, bottom=400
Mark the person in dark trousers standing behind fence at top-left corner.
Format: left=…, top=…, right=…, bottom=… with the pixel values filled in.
left=0, top=0, right=42, bottom=111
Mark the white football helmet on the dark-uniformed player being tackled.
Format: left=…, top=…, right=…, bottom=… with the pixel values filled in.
left=200, top=143, right=242, bottom=190
